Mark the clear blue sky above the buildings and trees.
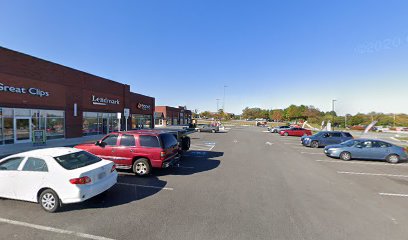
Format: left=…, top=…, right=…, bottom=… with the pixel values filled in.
left=0, top=0, right=408, bottom=114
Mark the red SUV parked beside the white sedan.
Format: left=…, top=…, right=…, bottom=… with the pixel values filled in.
left=75, top=130, right=180, bottom=176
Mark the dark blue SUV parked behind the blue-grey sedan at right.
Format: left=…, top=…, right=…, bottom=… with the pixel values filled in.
left=300, top=131, right=353, bottom=148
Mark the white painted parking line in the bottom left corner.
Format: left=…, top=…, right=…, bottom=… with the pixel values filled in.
left=0, top=218, right=114, bottom=240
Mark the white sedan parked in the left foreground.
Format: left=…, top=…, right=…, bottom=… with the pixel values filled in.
left=0, top=148, right=118, bottom=212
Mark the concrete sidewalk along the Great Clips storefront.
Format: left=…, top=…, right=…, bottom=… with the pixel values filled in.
left=0, top=135, right=105, bottom=158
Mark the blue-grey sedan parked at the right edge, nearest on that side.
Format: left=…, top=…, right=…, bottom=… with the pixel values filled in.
left=324, top=139, right=408, bottom=163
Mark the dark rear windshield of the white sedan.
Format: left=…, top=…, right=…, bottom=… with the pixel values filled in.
left=54, top=151, right=102, bottom=170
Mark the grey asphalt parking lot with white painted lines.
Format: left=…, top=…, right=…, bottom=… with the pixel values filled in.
left=0, top=127, right=408, bottom=240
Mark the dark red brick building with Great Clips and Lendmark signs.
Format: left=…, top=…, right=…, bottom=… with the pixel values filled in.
left=0, top=47, right=155, bottom=145
